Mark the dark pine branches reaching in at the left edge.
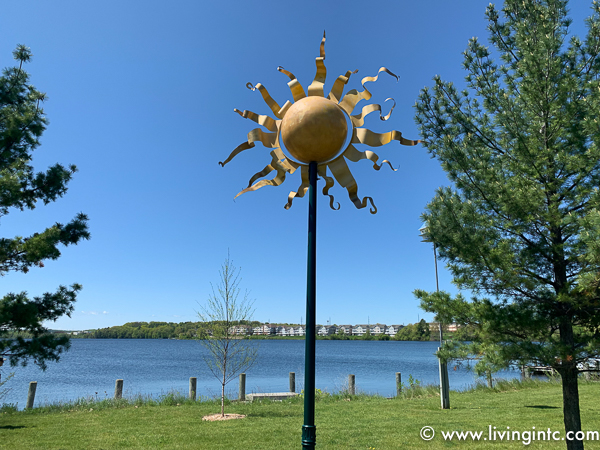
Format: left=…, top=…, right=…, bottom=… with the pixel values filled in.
left=0, top=45, right=90, bottom=369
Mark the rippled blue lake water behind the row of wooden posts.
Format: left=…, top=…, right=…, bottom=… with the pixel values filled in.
left=2, top=339, right=519, bottom=409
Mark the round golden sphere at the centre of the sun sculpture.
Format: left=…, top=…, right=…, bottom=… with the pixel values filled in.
left=281, top=97, right=348, bottom=164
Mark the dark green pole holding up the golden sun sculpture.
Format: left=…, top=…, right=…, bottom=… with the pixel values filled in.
left=302, top=162, right=317, bottom=450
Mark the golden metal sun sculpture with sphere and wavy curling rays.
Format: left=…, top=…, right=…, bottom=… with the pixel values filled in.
left=219, top=33, right=421, bottom=214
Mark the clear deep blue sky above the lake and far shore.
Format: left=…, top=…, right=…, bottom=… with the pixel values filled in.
left=0, top=0, right=591, bottom=330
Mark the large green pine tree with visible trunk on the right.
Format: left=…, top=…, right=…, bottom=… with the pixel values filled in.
left=415, top=0, right=600, bottom=449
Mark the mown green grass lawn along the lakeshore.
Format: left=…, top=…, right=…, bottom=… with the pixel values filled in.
left=0, top=381, right=600, bottom=450
